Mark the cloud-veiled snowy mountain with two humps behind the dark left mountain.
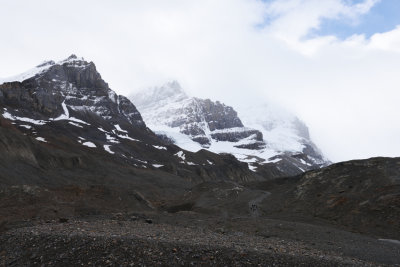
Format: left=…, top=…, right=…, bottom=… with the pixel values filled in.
left=131, top=81, right=328, bottom=174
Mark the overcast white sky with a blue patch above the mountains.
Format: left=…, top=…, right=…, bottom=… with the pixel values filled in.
left=0, top=0, right=400, bottom=161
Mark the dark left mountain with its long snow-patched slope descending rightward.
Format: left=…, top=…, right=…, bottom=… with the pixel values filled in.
left=0, top=55, right=261, bottom=181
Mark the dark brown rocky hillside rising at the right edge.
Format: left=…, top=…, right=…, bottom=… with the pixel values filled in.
left=293, top=158, right=400, bottom=239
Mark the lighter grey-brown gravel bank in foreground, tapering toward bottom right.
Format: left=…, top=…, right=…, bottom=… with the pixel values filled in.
left=0, top=220, right=386, bottom=266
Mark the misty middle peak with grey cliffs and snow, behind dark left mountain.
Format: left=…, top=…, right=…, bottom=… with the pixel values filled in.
left=132, top=81, right=264, bottom=150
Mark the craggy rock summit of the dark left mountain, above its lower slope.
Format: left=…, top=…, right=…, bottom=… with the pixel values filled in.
left=0, top=55, right=146, bottom=128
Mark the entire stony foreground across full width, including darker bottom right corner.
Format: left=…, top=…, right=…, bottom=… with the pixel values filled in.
left=0, top=215, right=400, bottom=266
